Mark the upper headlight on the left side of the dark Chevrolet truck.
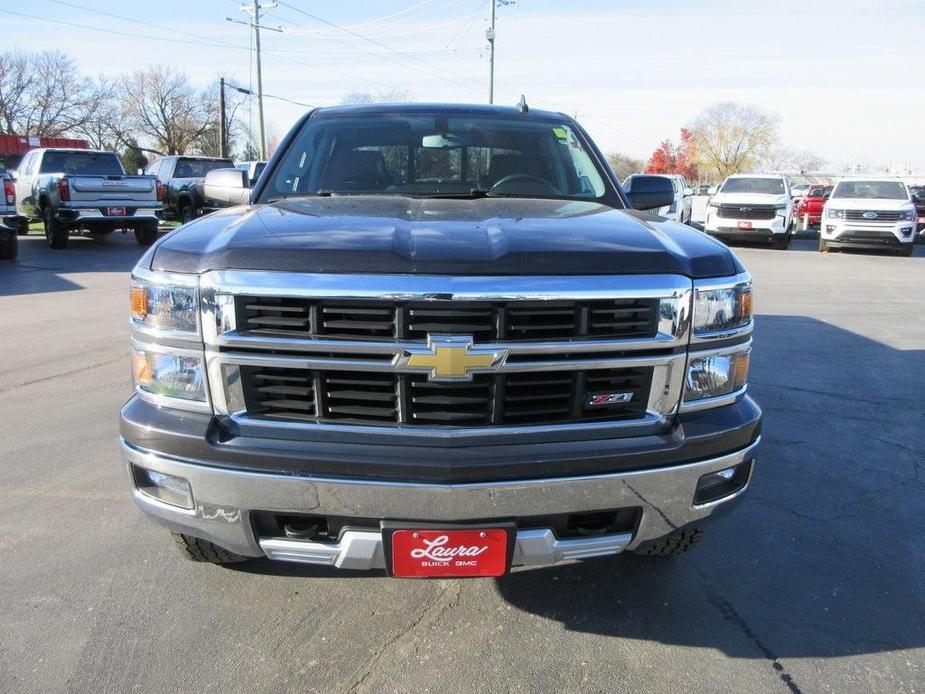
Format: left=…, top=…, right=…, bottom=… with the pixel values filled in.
left=131, top=270, right=199, bottom=335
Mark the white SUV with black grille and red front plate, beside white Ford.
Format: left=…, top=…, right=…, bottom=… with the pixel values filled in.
left=703, top=174, right=793, bottom=250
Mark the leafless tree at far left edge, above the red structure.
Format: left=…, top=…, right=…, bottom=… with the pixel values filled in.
left=0, top=51, right=100, bottom=137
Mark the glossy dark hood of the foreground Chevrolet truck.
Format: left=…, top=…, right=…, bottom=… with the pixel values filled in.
left=152, top=196, right=742, bottom=277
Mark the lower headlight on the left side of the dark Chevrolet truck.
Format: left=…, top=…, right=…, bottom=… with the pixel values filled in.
left=132, top=342, right=208, bottom=405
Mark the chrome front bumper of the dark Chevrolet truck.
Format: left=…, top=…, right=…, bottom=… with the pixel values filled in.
left=122, top=439, right=760, bottom=569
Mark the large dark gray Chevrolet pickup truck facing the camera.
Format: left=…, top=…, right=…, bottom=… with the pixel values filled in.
left=121, top=105, right=761, bottom=577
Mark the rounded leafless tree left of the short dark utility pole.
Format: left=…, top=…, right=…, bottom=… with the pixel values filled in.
left=122, top=66, right=215, bottom=154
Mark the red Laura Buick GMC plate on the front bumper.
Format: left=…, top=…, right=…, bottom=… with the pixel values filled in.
left=392, top=528, right=509, bottom=578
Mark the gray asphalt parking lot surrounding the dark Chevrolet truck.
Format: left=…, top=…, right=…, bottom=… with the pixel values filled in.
left=0, top=232, right=925, bottom=692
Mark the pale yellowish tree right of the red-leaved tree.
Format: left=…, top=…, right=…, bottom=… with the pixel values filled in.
left=690, top=102, right=777, bottom=179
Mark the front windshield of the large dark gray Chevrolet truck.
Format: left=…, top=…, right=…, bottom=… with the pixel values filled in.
left=261, top=112, right=610, bottom=200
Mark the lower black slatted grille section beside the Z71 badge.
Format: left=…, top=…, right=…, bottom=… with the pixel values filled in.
left=240, top=366, right=652, bottom=427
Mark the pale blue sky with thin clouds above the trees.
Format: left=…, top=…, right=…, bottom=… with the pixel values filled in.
left=0, top=0, right=925, bottom=174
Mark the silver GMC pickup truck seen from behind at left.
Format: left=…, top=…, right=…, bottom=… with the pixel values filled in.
left=15, top=149, right=164, bottom=248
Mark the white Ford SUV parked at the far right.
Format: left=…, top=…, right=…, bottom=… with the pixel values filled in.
left=819, top=178, right=917, bottom=255
